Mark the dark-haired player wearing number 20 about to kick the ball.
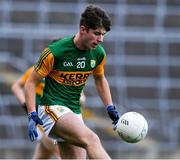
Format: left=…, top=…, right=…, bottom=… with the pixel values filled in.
left=25, top=5, right=119, bottom=159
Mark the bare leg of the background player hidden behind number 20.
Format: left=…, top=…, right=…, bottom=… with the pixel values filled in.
left=33, top=136, right=61, bottom=159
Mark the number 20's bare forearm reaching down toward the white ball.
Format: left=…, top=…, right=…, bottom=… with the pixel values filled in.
left=95, top=77, right=112, bottom=106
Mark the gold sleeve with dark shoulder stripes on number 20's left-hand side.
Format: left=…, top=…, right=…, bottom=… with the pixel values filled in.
left=34, top=48, right=54, bottom=77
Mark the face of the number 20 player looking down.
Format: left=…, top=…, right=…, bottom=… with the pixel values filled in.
left=82, top=28, right=106, bottom=49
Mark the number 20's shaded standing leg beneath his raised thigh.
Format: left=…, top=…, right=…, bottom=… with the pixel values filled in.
left=58, top=142, right=86, bottom=159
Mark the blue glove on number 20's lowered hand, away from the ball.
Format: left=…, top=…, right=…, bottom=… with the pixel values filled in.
left=28, top=112, right=43, bottom=141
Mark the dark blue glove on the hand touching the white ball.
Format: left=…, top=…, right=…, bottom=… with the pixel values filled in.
left=107, top=105, right=120, bottom=129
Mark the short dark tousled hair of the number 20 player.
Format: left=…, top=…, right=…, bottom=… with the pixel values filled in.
left=80, top=5, right=111, bottom=31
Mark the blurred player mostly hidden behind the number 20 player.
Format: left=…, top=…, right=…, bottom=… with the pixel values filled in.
left=11, top=67, right=61, bottom=159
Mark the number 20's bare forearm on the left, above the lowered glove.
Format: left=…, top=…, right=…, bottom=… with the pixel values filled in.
left=25, top=81, right=36, bottom=113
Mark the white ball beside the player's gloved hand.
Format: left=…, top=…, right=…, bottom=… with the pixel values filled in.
left=116, top=112, right=148, bottom=143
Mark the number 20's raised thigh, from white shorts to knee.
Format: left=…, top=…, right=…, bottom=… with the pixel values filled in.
left=50, top=112, right=99, bottom=147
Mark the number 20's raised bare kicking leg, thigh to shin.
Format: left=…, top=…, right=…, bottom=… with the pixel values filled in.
left=51, top=113, right=110, bottom=159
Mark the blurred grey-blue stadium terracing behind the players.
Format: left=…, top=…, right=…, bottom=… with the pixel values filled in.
left=0, top=0, right=180, bottom=159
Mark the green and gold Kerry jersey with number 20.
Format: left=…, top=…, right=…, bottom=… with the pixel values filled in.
left=35, top=37, right=106, bottom=113
